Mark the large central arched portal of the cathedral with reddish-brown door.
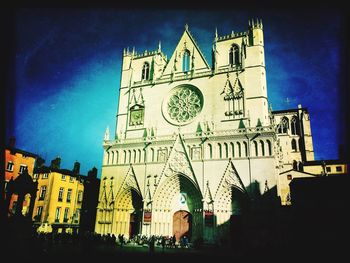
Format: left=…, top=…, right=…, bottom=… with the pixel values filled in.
left=151, top=174, right=203, bottom=240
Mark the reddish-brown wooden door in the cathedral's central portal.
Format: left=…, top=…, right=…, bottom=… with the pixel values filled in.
left=173, top=210, right=192, bottom=241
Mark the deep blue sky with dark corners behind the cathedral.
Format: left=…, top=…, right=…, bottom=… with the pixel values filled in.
left=6, top=8, right=344, bottom=177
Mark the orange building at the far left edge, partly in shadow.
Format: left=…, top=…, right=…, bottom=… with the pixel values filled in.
left=4, top=138, right=39, bottom=216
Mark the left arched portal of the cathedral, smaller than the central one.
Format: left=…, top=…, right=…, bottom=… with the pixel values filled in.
left=113, top=187, right=142, bottom=238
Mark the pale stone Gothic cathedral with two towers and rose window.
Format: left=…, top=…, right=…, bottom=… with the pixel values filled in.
left=95, top=20, right=314, bottom=242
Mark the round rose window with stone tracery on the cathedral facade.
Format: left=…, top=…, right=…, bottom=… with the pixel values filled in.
left=163, top=86, right=203, bottom=125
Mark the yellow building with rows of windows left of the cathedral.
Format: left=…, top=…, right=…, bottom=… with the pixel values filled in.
left=33, top=159, right=84, bottom=233
